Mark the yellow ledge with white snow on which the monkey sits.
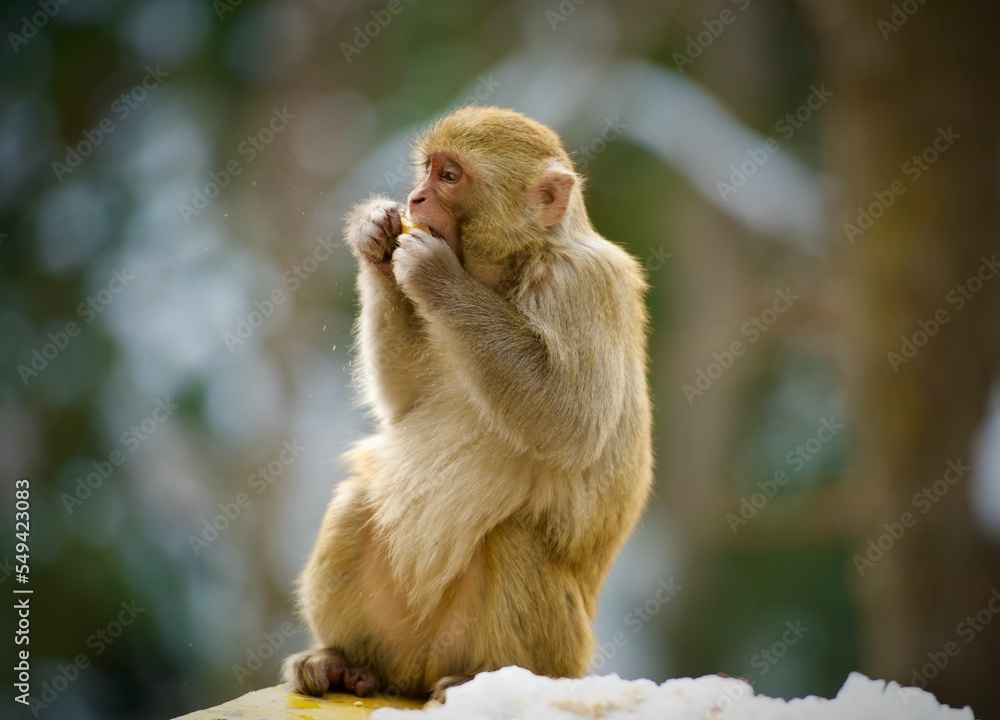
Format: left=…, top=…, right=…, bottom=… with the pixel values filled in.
left=175, top=666, right=975, bottom=720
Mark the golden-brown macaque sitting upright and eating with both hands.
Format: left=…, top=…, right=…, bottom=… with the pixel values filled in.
left=284, top=106, right=652, bottom=699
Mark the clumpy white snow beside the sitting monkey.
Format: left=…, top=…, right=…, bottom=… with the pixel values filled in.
left=372, top=667, right=975, bottom=720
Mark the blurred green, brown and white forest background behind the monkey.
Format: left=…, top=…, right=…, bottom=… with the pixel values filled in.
left=0, top=0, right=1000, bottom=718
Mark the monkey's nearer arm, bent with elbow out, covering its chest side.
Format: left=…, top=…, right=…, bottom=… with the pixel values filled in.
left=395, top=233, right=645, bottom=467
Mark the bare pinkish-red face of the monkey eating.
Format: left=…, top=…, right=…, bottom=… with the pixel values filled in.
left=407, top=153, right=466, bottom=253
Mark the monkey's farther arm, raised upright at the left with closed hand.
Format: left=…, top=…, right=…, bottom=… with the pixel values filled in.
left=345, top=197, right=424, bottom=424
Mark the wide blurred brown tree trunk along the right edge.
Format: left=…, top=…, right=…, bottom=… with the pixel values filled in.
left=808, top=0, right=1000, bottom=717
